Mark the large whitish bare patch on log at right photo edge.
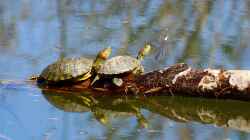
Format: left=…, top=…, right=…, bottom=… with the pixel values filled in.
left=225, top=70, right=250, bottom=91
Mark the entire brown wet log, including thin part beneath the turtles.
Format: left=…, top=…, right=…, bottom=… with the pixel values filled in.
left=36, top=63, right=250, bottom=100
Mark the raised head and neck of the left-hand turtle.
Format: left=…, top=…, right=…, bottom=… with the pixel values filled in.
left=93, top=47, right=112, bottom=71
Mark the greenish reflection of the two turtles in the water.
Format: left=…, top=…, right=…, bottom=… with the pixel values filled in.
left=42, top=90, right=148, bottom=128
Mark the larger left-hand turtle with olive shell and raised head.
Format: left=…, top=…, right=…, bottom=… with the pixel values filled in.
left=36, top=47, right=112, bottom=83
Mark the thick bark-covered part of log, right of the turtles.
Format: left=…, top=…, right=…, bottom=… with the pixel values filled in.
left=126, top=64, right=250, bottom=100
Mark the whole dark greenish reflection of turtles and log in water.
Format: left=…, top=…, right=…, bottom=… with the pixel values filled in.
left=43, top=91, right=250, bottom=132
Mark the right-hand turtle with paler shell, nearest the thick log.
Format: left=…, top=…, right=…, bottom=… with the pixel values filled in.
left=91, top=44, right=151, bottom=87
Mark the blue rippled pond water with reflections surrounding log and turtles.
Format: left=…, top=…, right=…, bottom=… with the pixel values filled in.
left=0, top=0, right=250, bottom=140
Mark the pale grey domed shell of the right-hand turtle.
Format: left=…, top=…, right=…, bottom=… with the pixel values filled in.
left=98, top=56, right=141, bottom=74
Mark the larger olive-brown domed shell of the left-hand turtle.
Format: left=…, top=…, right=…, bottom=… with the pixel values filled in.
left=40, top=57, right=93, bottom=82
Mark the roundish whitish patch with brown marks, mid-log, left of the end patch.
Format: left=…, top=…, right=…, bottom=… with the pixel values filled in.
left=198, top=75, right=218, bottom=91
